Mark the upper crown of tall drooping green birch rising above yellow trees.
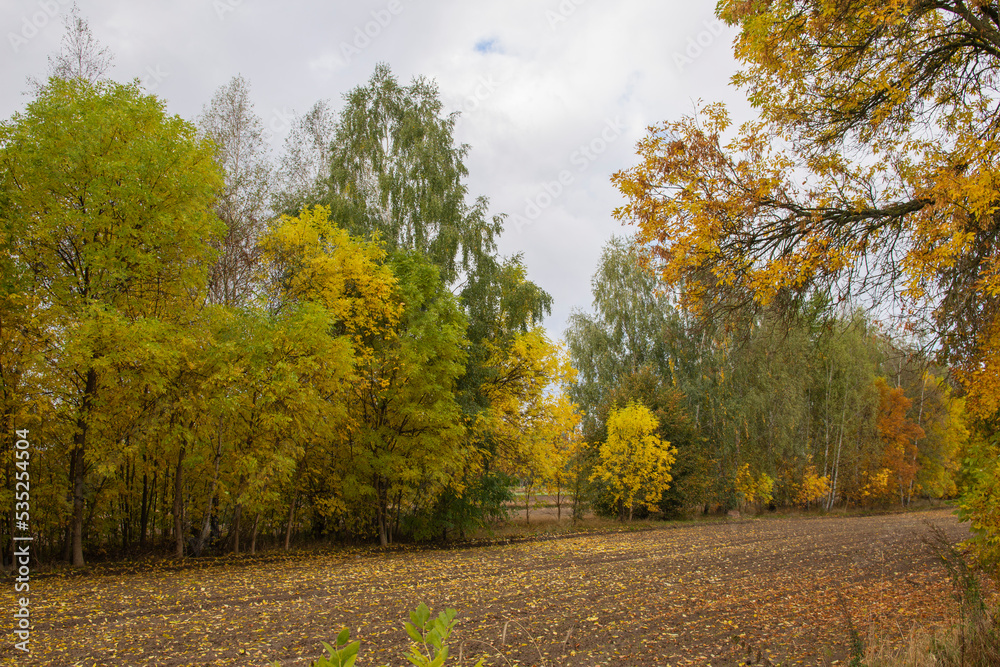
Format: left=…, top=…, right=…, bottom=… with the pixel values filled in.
left=319, top=65, right=501, bottom=287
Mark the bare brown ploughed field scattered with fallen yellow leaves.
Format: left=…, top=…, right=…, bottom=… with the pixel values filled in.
left=0, top=510, right=967, bottom=667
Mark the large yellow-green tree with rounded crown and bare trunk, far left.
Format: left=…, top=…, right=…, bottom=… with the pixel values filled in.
left=0, top=78, right=221, bottom=565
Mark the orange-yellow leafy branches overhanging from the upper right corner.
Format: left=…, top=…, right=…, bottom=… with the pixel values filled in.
left=614, top=0, right=1000, bottom=410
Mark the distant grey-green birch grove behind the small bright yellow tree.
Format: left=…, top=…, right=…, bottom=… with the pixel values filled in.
left=567, top=241, right=964, bottom=513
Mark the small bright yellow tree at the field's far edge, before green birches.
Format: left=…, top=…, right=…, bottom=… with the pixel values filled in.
left=591, top=403, right=677, bottom=521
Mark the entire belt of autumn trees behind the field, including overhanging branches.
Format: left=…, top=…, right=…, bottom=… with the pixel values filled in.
left=0, top=1, right=1000, bottom=584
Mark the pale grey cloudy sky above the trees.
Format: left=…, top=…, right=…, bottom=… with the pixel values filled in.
left=0, top=0, right=748, bottom=338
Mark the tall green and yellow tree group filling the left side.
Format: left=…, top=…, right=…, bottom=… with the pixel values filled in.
left=0, top=21, right=579, bottom=565
